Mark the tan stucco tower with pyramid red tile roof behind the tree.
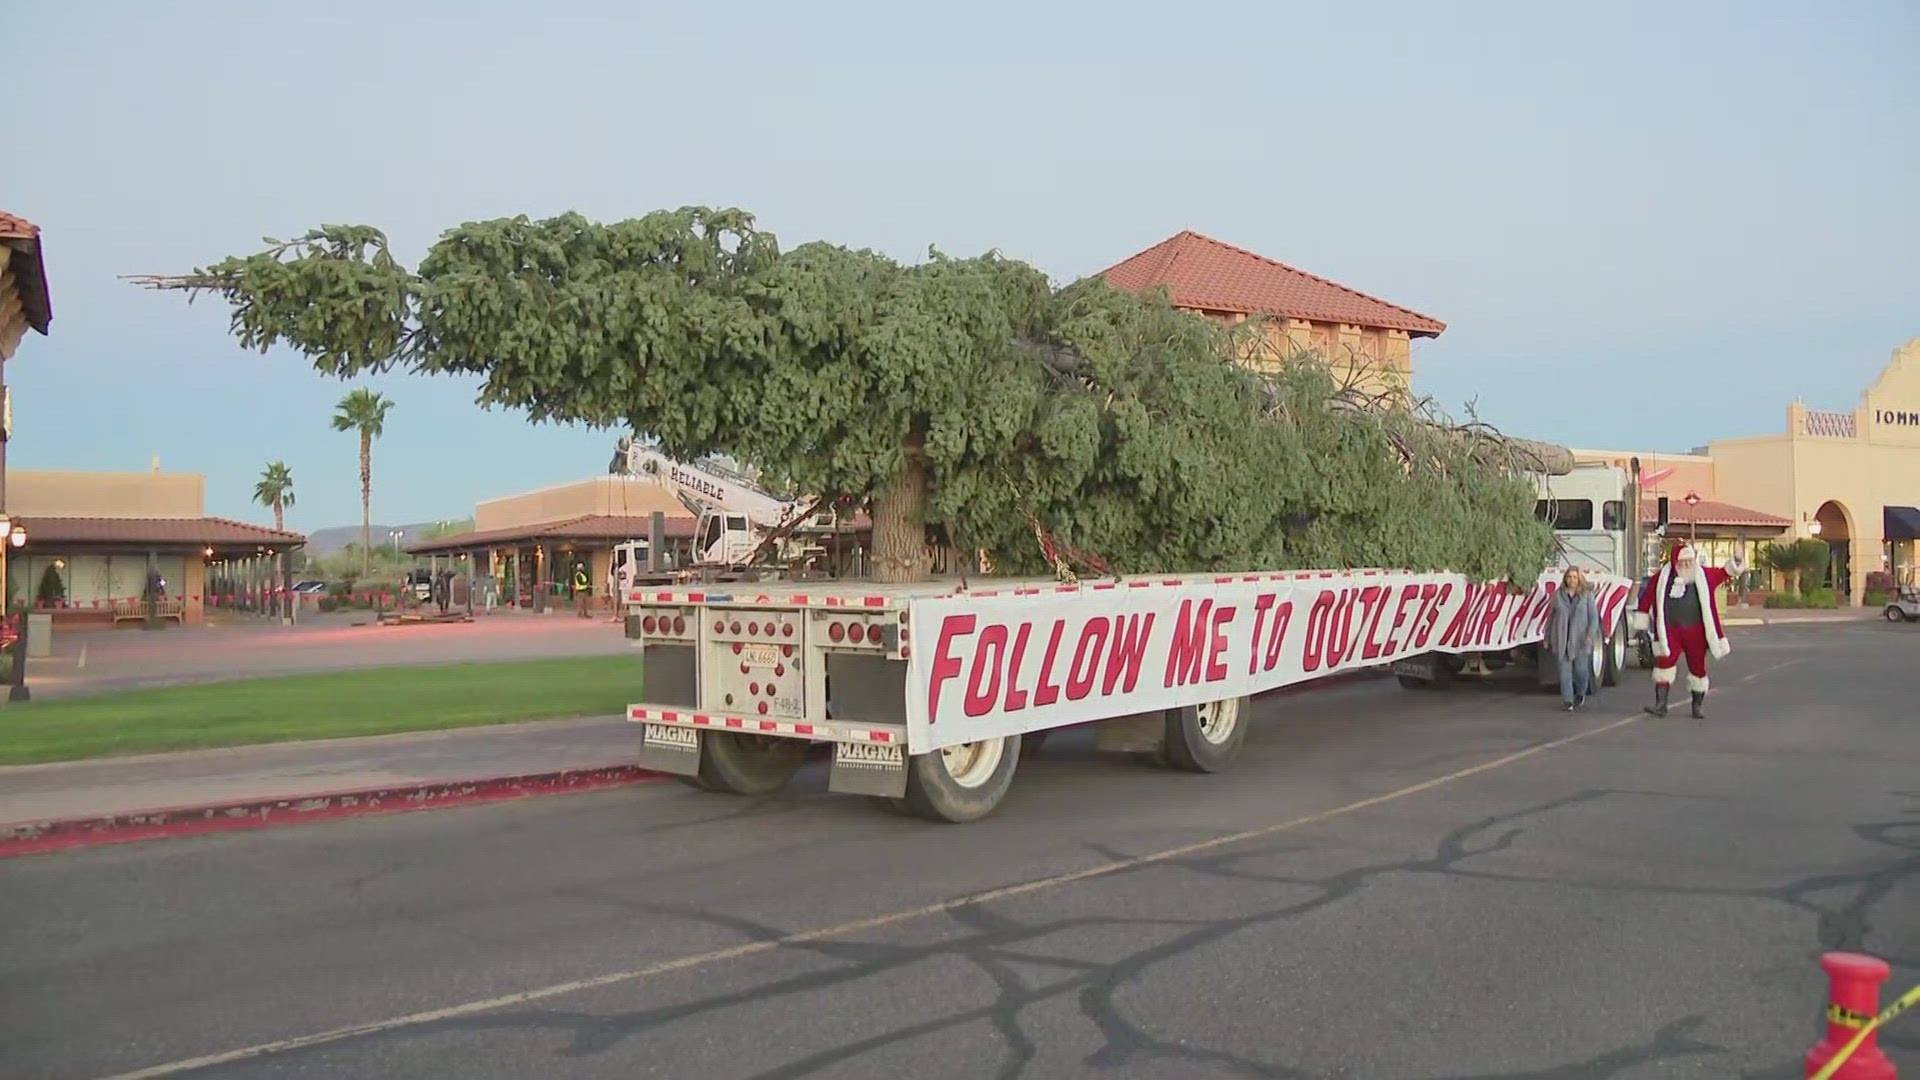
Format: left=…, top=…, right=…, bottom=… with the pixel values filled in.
left=1098, top=231, right=1446, bottom=392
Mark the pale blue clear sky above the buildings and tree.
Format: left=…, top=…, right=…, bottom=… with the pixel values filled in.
left=0, top=0, right=1920, bottom=530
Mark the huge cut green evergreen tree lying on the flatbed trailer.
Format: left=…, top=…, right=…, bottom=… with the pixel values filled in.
left=135, top=208, right=1551, bottom=580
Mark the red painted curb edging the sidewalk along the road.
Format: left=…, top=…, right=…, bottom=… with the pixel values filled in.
left=0, top=765, right=666, bottom=859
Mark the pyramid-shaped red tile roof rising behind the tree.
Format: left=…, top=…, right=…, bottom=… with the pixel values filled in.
left=1100, top=229, right=1446, bottom=338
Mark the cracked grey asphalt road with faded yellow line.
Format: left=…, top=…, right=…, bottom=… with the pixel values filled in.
left=0, top=625, right=1920, bottom=1080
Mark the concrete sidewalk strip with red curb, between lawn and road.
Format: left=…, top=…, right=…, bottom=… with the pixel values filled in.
left=0, top=717, right=649, bottom=855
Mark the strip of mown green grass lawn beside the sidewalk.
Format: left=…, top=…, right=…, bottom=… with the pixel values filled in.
left=0, top=655, right=639, bottom=765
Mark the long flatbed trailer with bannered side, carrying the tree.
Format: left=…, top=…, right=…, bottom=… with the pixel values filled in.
left=626, top=569, right=1628, bottom=822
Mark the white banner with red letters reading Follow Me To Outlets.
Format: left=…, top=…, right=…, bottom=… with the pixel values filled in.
left=906, top=569, right=1632, bottom=751
